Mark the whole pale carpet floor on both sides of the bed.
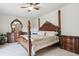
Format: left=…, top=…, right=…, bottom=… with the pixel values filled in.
left=0, top=43, right=78, bottom=56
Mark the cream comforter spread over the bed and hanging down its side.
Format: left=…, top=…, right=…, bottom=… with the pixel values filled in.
left=22, top=35, right=59, bottom=55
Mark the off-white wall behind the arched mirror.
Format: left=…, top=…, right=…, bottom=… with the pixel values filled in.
left=0, top=16, right=33, bottom=33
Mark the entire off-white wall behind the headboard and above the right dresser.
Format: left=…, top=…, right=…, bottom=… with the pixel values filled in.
left=33, top=4, right=79, bottom=36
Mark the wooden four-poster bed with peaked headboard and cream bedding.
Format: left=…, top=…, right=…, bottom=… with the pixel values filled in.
left=17, top=9, right=60, bottom=56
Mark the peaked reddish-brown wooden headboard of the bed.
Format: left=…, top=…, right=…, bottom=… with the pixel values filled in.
left=39, top=21, right=59, bottom=31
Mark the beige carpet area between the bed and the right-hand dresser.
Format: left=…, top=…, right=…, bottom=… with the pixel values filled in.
left=37, top=47, right=78, bottom=56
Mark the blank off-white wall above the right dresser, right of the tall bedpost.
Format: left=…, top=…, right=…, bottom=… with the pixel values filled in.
left=61, top=3, right=79, bottom=36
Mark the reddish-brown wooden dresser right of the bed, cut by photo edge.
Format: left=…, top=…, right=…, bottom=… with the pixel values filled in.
left=60, top=35, right=79, bottom=54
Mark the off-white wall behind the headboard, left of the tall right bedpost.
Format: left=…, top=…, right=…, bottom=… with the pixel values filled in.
left=33, top=10, right=58, bottom=30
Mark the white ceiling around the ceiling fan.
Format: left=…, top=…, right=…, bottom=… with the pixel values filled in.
left=0, top=3, right=68, bottom=18
